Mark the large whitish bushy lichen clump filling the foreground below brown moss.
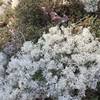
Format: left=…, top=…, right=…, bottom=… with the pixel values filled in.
left=0, top=26, right=100, bottom=100
